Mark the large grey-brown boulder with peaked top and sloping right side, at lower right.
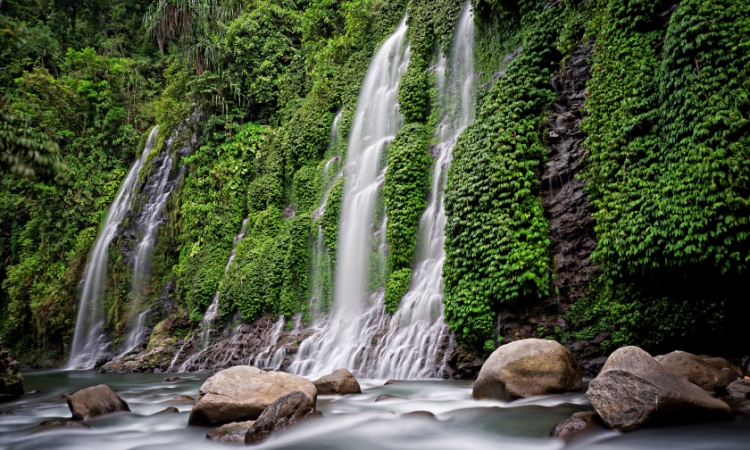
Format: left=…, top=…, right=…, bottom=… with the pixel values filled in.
left=586, top=347, right=732, bottom=431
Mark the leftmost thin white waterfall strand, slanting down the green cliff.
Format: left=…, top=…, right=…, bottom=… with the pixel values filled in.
left=66, top=127, right=159, bottom=369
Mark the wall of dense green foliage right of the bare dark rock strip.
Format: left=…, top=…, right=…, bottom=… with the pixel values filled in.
left=573, top=0, right=750, bottom=347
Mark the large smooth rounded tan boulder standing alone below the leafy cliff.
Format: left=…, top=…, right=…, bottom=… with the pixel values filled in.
left=472, top=339, right=582, bottom=400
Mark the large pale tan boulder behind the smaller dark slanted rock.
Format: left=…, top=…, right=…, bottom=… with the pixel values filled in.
left=188, top=366, right=318, bottom=427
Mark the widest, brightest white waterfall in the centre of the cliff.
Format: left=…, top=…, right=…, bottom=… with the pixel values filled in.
left=289, top=18, right=409, bottom=376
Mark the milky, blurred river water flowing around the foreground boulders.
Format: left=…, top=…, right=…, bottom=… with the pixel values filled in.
left=0, top=370, right=750, bottom=450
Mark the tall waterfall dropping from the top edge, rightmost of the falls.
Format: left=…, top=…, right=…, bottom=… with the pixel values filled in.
left=366, top=3, right=475, bottom=379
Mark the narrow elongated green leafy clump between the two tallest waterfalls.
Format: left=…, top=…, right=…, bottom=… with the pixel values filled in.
left=383, top=123, right=431, bottom=312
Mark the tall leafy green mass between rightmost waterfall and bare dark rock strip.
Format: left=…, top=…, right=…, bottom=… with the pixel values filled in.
left=443, top=0, right=559, bottom=348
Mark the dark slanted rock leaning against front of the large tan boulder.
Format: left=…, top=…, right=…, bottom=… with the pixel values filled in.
left=245, top=391, right=321, bottom=444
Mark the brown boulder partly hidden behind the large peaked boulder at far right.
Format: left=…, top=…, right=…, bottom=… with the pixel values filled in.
left=654, top=350, right=740, bottom=392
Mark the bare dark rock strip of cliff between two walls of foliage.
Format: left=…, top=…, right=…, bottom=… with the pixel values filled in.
left=496, top=43, right=606, bottom=375
